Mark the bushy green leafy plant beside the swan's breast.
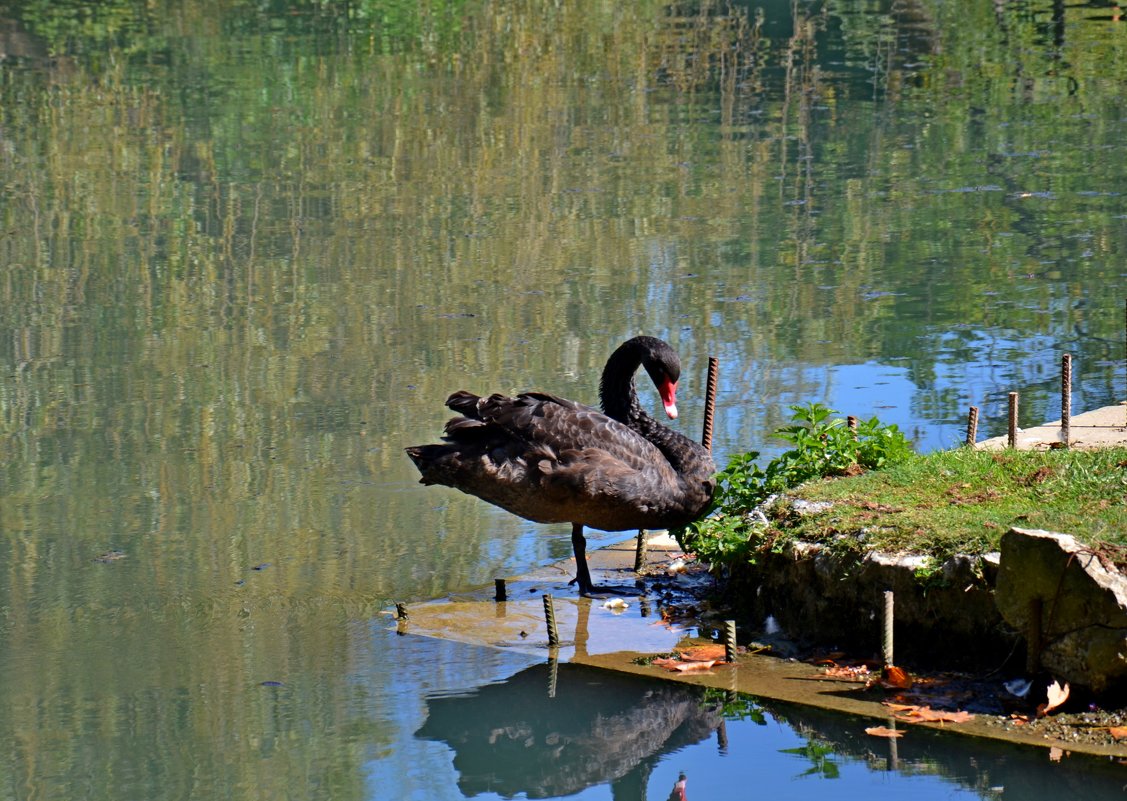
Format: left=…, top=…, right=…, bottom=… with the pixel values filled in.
left=673, top=403, right=912, bottom=564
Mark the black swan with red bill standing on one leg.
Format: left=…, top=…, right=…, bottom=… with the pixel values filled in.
left=407, top=337, right=716, bottom=595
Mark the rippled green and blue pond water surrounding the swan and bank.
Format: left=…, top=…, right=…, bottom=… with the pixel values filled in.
left=0, top=0, right=1127, bottom=799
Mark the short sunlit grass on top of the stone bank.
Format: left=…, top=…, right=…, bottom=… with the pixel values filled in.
left=772, top=447, right=1127, bottom=562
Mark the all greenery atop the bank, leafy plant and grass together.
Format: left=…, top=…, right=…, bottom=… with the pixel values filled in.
left=673, top=403, right=1127, bottom=572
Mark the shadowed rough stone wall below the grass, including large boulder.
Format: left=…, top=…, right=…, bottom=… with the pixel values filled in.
left=729, top=528, right=1127, bottom=695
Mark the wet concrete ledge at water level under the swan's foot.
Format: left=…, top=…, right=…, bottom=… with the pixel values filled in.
left=397, top=534, right=1127, bottom=758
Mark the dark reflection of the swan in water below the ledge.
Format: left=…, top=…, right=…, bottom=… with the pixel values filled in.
left=416, top=662, right=724, bottom=801
